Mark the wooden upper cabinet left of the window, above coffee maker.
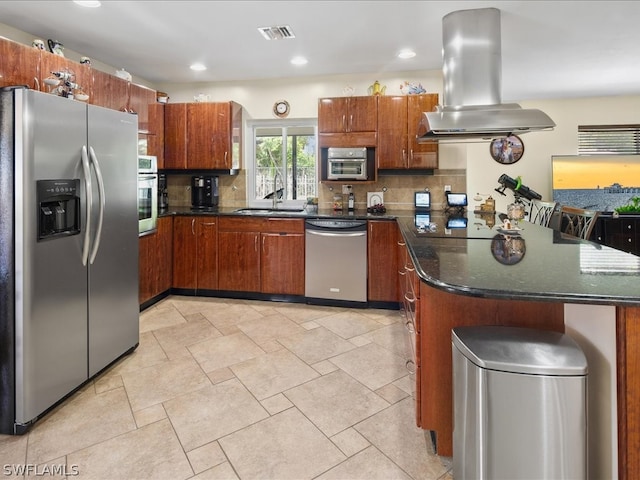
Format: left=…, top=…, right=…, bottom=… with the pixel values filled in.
left=164, top=102, right=242, bottom=171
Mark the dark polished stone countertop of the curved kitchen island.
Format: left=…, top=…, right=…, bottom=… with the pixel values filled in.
left=397, top=212, right=640, bottom=306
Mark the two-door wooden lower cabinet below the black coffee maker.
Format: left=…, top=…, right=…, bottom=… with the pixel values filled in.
left=173, top=216, right=218, bottom=290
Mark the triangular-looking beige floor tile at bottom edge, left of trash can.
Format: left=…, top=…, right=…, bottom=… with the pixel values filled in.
left=317, top=446, right=416, bottom=480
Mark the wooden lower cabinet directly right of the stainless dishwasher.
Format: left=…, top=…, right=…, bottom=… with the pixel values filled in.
left=367, top=220, right=400, bottom=302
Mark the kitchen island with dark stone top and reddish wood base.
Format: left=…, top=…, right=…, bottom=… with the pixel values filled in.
left=398, top=212, right=640, bottom=479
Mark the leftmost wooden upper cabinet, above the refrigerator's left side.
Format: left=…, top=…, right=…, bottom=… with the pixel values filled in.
left=0, top=38, right=43, bottom=90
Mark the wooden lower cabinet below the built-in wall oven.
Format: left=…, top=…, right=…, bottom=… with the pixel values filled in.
left=138, top=217, right=173, bottom=304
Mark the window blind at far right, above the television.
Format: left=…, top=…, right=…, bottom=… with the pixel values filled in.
left=578, top=125, right=640, bottom=155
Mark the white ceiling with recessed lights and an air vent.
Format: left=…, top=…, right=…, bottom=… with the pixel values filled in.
left=0, top=0, right=640, bottom=101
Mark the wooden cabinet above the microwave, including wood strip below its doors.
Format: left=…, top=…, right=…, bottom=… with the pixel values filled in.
left=318, top=95, right=378, bottom=147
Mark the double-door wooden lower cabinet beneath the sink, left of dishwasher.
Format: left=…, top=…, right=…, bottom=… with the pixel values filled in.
left=218, top=217, right=304, bottom=295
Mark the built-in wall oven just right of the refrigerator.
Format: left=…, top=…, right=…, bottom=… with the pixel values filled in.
left=138, top=155, right=158, bottom=236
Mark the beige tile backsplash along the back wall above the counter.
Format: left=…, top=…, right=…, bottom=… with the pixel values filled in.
left=167, top=169, right=467, bottom=210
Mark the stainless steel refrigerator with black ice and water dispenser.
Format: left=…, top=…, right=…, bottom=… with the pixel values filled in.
left=0, top=87, right=139, bottom=434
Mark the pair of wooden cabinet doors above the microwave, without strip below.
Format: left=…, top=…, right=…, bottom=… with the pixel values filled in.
left=318, top=96, right=378, bottom=133
